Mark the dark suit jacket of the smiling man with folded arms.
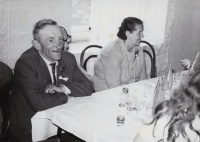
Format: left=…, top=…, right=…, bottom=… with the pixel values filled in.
left=10, top=47, right=94, bottom=142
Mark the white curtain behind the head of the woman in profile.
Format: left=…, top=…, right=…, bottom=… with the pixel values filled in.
left=90, top=0, right=168, bottom=45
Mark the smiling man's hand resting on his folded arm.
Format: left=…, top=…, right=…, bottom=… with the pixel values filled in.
left=44, top=84, right=66, bottom=93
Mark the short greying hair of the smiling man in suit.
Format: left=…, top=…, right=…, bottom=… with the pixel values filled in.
left=32, top=19, right=57, bottom=40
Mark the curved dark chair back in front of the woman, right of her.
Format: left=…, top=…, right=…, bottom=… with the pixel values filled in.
left=140, top=41, right=157, bottom=78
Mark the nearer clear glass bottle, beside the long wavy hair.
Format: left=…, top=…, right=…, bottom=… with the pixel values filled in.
left=153, top=77, right=165, bottom=112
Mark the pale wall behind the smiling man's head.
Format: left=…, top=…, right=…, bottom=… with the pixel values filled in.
left=0, top=0, right=72, bottom=68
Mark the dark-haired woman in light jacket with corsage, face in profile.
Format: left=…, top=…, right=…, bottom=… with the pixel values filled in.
left=93, top=17, right=146, bottom=91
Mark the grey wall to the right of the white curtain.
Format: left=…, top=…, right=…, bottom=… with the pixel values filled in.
left=169, top=0, right=200, bottom=70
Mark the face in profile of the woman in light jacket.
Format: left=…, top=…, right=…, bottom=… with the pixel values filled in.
left=126, top=25, right=144, bottom=47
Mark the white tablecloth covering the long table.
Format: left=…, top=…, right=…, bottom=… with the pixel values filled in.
left=31, top=78, right=158, bottom=142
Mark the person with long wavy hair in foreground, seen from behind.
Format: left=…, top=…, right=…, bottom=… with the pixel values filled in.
left=133, top=68, right=200, bottom=142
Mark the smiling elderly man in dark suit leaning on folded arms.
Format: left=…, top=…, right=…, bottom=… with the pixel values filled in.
left=10, top=19, right=94, bottom=142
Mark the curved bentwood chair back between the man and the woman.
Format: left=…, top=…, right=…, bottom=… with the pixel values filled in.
left=80, top=45, right=102, bottom=71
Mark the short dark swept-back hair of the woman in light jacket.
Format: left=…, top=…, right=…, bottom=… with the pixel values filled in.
left=117, top=17, right=143, bottom=40
